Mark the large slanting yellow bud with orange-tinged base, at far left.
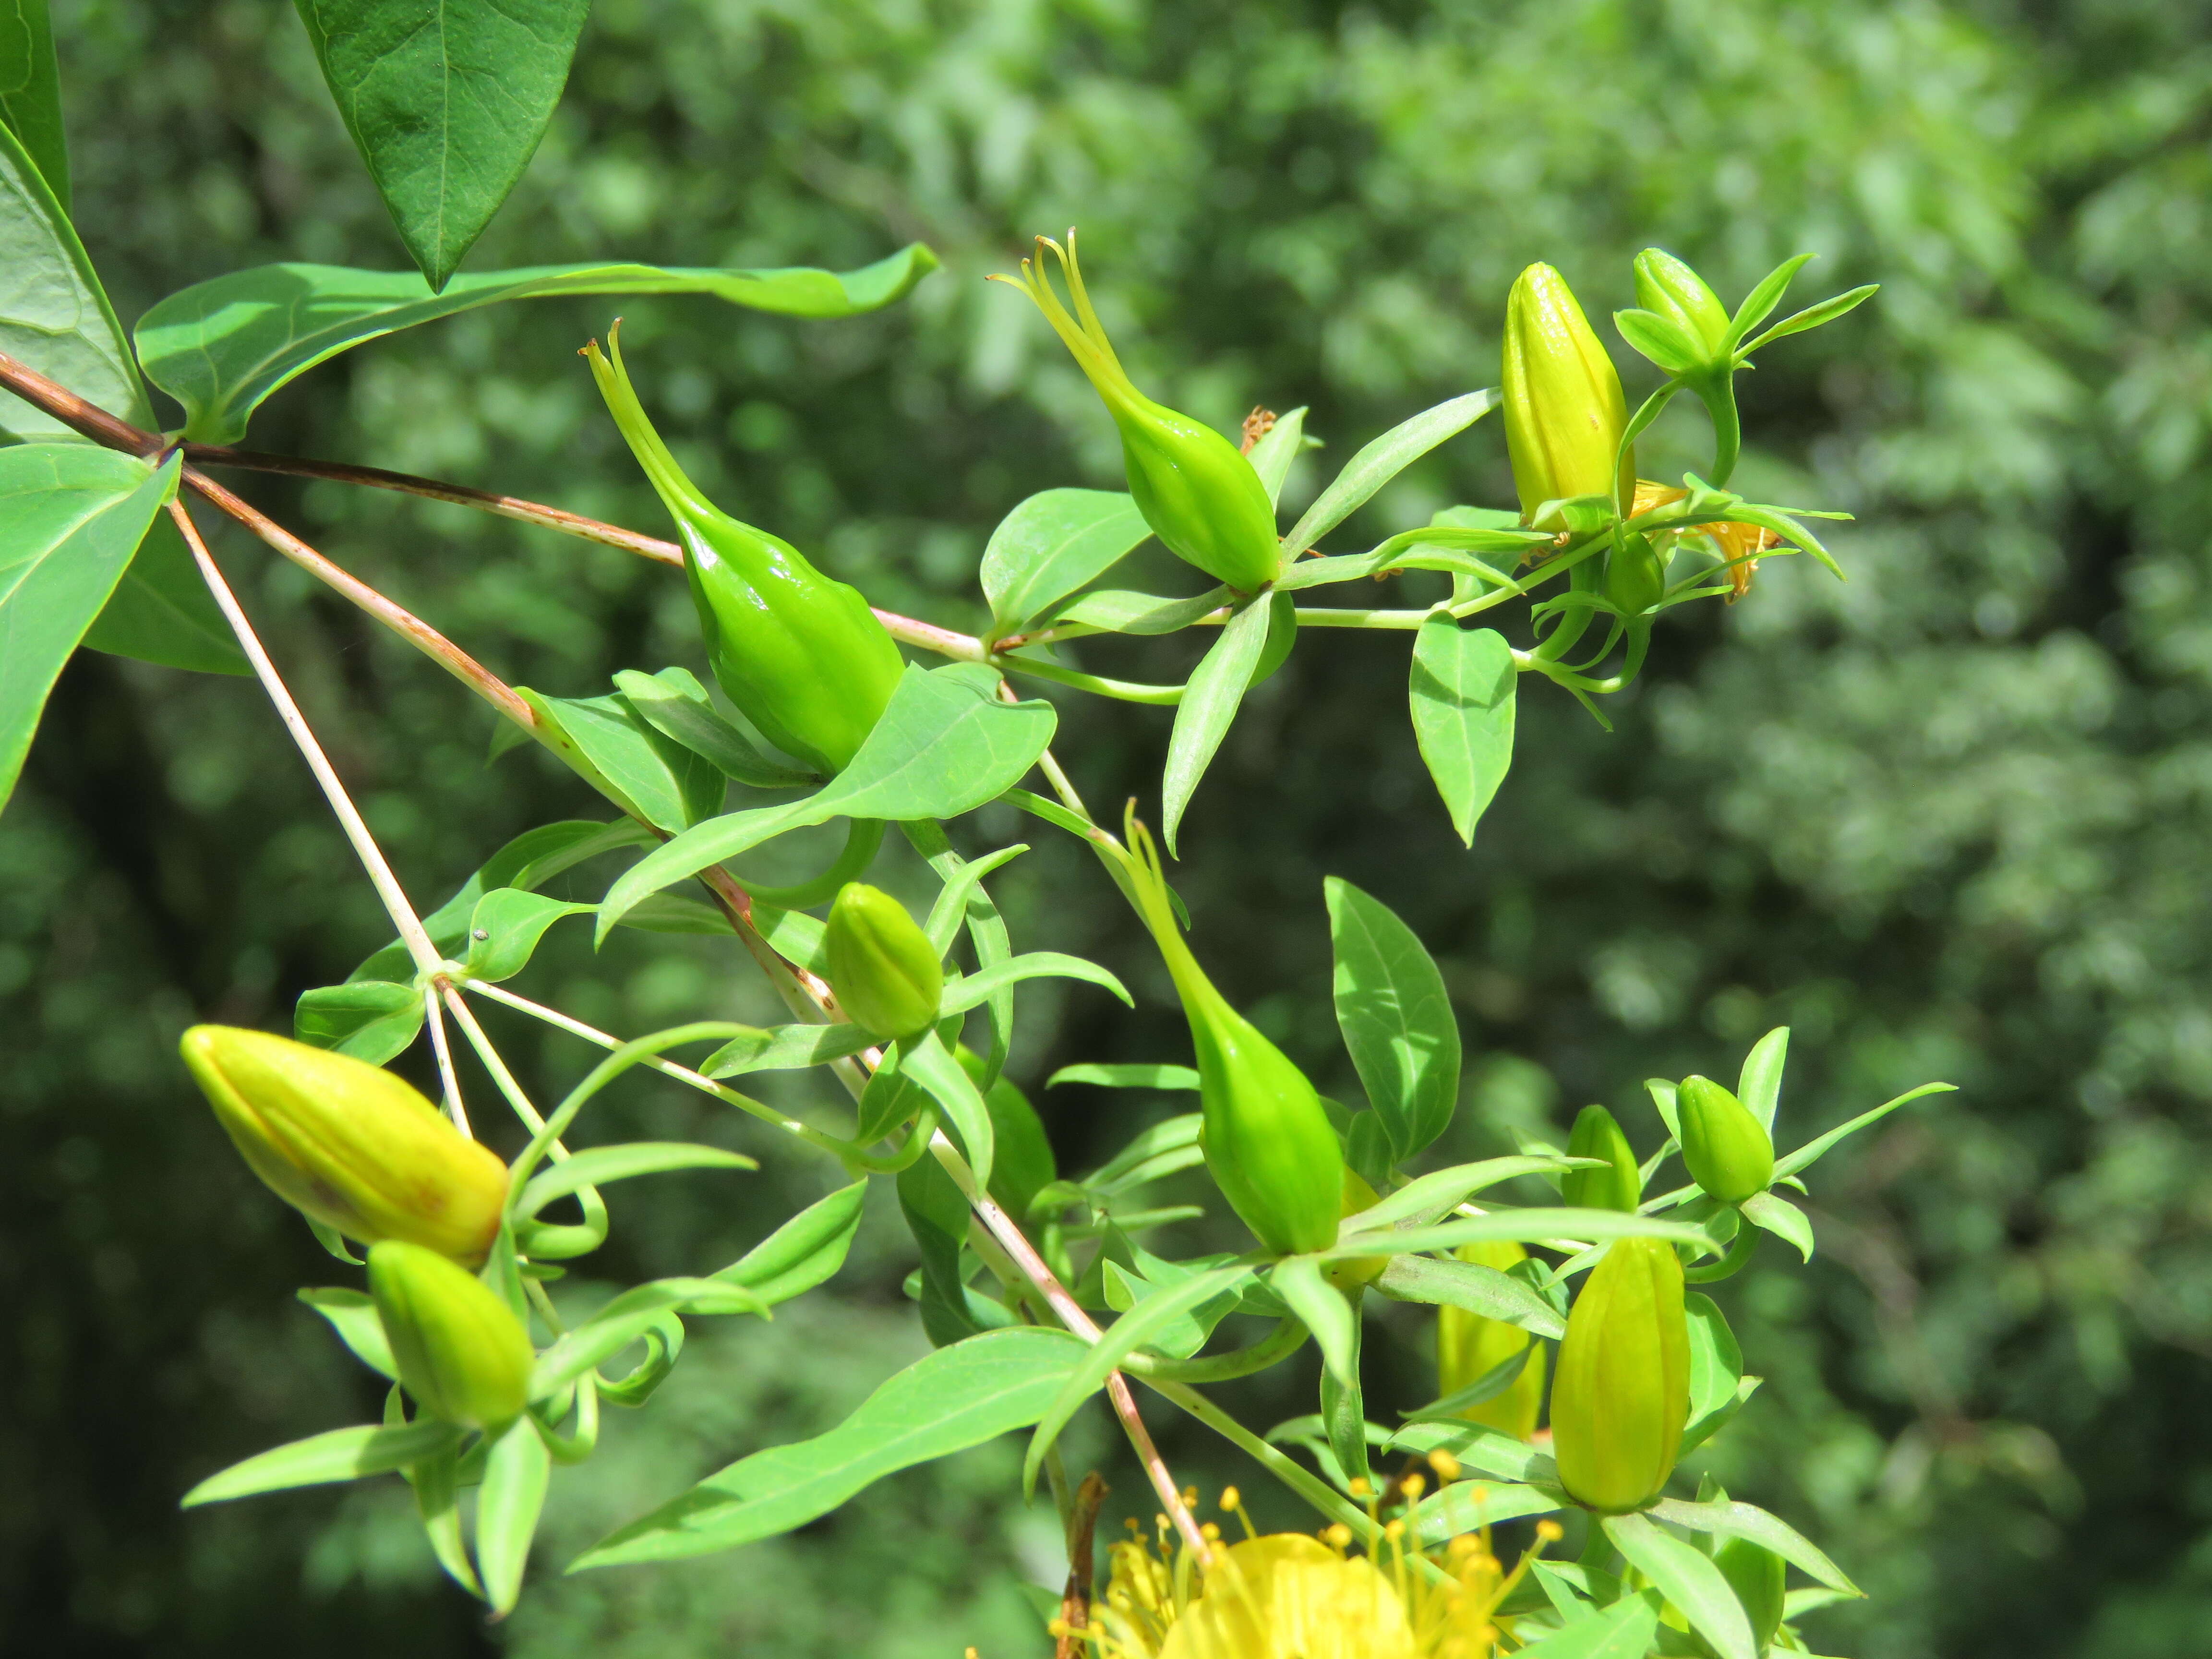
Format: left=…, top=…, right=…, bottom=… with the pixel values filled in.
left=179, top=1026, right=506, bottom=1263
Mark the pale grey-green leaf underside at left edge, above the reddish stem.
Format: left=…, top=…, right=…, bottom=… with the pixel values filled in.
left=0, top=126, right=153, bottom=443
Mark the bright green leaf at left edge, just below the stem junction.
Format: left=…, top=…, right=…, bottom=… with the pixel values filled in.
left=0, top=449, right=179, bottom=805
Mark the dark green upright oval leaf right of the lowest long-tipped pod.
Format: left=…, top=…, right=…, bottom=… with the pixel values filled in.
left=1325, top=876, right=1460, bottom=1164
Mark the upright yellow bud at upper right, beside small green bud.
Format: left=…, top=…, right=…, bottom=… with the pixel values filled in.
left=1504, top=265, right=1637, bottom=516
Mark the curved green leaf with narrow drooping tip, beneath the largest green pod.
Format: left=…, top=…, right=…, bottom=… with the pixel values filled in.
left=600, top=663, right=1055, bottom=940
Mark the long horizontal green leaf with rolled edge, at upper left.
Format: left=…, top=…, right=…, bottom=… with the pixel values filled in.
left=136, top=243, right=938, bottom=445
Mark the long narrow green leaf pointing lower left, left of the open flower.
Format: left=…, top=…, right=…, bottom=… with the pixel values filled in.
left=571, top=1329, right=1084, bottom=1571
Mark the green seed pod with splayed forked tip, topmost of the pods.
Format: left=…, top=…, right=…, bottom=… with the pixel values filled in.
left=996, top=230, right=1283, bottom=593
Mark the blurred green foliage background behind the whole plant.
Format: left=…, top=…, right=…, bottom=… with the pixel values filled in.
left=0, top=0, right=2212, bottom=1659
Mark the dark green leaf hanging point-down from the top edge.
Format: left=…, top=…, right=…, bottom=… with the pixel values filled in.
left=296, top=0, right=590, bottom=288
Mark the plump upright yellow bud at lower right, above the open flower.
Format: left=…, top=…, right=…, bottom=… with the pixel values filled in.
left=1551, top=1238, right=1690, bottom=1515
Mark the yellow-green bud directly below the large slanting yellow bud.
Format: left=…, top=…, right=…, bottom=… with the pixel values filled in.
left=370, top=1238, right=538, bottom=1429
